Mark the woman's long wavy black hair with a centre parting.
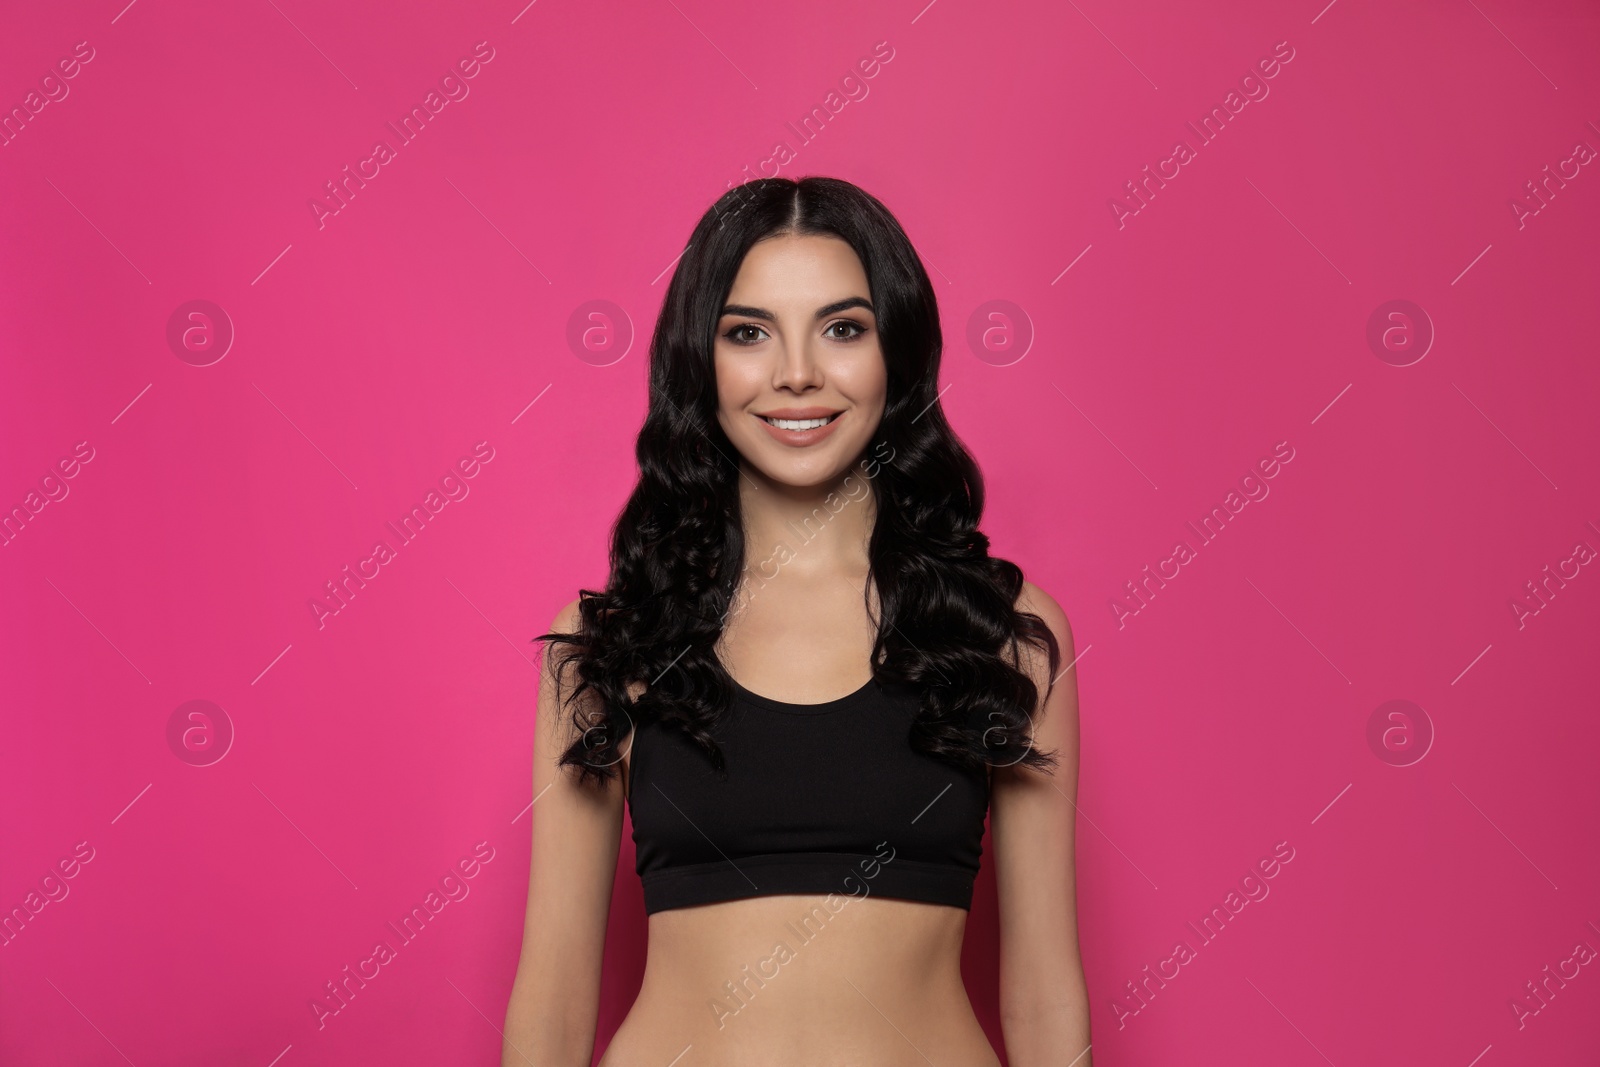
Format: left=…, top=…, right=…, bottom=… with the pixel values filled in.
left=533, top=178, right=1061, bottom=782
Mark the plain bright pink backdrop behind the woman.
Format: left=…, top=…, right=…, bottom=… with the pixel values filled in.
left=0, top=0, right=1600, bottom=1067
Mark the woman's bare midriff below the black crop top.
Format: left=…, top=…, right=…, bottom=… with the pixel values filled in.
left=600, top=893, right=1000, bottom=1067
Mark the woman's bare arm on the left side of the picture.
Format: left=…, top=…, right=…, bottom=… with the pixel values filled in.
left=501, top=600, right=624, bottom=1067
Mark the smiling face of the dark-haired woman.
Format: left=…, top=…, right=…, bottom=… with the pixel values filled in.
left=715, top=234, right=888, bottom=486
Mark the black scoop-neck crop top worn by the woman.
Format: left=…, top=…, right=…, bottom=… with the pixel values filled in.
left=627, top=680, right=989, bottom=913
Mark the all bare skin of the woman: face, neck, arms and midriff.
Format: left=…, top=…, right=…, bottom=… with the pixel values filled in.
left=501, top=235, right=1091, bottom=1067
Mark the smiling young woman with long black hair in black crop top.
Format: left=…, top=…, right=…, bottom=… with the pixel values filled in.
left=502, top=178, right=1090, bottom=1067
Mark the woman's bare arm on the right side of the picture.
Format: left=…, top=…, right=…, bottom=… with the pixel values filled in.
left=989, top=582, right=1091, bottom=1067
